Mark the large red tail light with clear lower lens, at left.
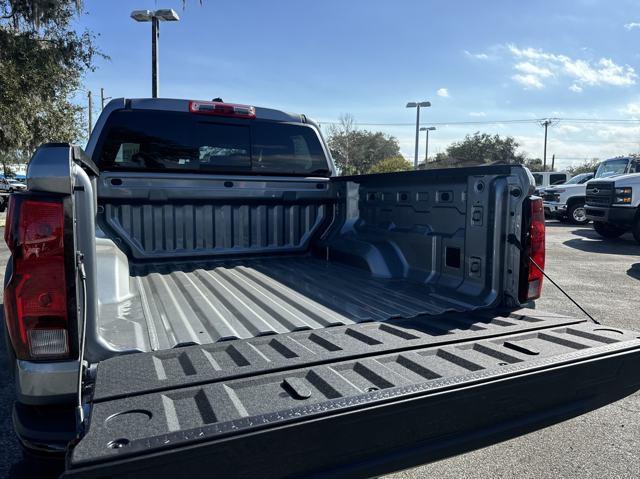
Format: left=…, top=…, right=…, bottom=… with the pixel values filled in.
left=4, top=195, right=69, bottom=360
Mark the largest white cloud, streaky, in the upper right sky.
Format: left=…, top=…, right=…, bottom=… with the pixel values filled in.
left=507, top=45, right=638, bottom=93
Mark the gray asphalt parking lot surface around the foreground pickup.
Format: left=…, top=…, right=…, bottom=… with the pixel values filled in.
left=0, top=222, right=640, bottom=479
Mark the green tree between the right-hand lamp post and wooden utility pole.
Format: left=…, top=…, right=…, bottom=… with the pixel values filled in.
left=447, top=131, right=525, bottom=164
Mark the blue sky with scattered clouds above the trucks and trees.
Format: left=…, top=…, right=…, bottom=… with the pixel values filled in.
left=77, top=0, right=640, bottom=167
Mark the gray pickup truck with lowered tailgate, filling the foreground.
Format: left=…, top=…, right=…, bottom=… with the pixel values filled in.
left=5, top=99, right=640, bottom=478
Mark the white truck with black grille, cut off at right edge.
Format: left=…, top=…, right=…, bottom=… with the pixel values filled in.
left=586, top=157, right=640, bottom=242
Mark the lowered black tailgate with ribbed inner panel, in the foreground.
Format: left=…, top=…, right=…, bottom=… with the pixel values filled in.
left=65, top=310, right=640, bottom=478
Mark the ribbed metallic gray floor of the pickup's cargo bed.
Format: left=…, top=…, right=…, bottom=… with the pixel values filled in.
left=101, top=256, right=474, bottom=350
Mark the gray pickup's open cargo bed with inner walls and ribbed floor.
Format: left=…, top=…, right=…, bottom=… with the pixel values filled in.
left=88, top=166, right=516, bottom=360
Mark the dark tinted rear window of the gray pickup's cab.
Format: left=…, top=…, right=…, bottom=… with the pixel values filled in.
left=95, top=110, right=330, bottom=176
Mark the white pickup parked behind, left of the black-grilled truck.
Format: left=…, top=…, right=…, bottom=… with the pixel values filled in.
left=541, top=173, right=594, bottom=225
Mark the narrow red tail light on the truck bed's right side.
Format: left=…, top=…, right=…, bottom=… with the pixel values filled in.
left=520, top=198, right=545, bottom=302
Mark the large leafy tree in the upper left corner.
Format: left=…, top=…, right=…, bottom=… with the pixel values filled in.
left=0, top=0, right=101, bottom=171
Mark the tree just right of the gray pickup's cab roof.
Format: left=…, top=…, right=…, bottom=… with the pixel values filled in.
left=327, top=114, right=400, bottom=175
